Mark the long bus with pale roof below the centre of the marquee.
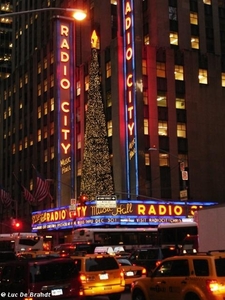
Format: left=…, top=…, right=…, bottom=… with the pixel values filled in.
left=72, top=227, right=157, bottom=251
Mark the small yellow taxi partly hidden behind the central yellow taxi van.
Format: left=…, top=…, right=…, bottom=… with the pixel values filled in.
left=116, top=257, right=147, bottom=288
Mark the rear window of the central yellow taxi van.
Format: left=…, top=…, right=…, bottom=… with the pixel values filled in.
left=86, top=257, right=119, bottom=272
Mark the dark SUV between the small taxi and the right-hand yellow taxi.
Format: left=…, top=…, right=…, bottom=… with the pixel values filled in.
left=129, top=247, right=177, bottom=275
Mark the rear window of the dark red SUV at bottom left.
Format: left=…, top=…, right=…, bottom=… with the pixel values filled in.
left=30, top=261, right=79, bottom=282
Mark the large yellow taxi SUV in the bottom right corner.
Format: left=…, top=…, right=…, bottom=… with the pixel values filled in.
left=131, top=252, right=225, bottom=300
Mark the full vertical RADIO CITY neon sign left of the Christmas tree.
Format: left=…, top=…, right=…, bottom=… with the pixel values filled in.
left=54, top=17, right=75, bottom=206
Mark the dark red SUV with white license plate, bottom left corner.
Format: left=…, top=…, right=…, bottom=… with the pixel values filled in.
left=0, top=258, right=84, bottom=300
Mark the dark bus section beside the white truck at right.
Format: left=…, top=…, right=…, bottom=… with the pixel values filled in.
left=158, top=222, right=198, bottom=249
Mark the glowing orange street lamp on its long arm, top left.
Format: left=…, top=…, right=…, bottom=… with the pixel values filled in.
left=0, top=7, right=87, bottom=21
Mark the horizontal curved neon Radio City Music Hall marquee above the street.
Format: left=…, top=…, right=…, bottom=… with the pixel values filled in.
left=32, top=200, right=216, bottom=231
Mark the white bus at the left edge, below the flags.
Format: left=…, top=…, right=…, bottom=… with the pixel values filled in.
left=0, top=232, right=43, bottom=253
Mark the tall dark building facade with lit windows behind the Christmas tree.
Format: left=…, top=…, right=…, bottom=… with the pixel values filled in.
left=0, top=0, right=225, bottom=232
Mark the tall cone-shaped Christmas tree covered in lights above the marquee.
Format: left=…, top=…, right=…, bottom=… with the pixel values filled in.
left=81, top=32, right=114, bottom=200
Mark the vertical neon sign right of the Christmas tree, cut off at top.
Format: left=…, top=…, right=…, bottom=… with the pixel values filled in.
left=122, top=0, right=138, bottom=197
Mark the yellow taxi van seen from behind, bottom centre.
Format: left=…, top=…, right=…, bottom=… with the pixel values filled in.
left=71, top=253, right=125, bottom=300
